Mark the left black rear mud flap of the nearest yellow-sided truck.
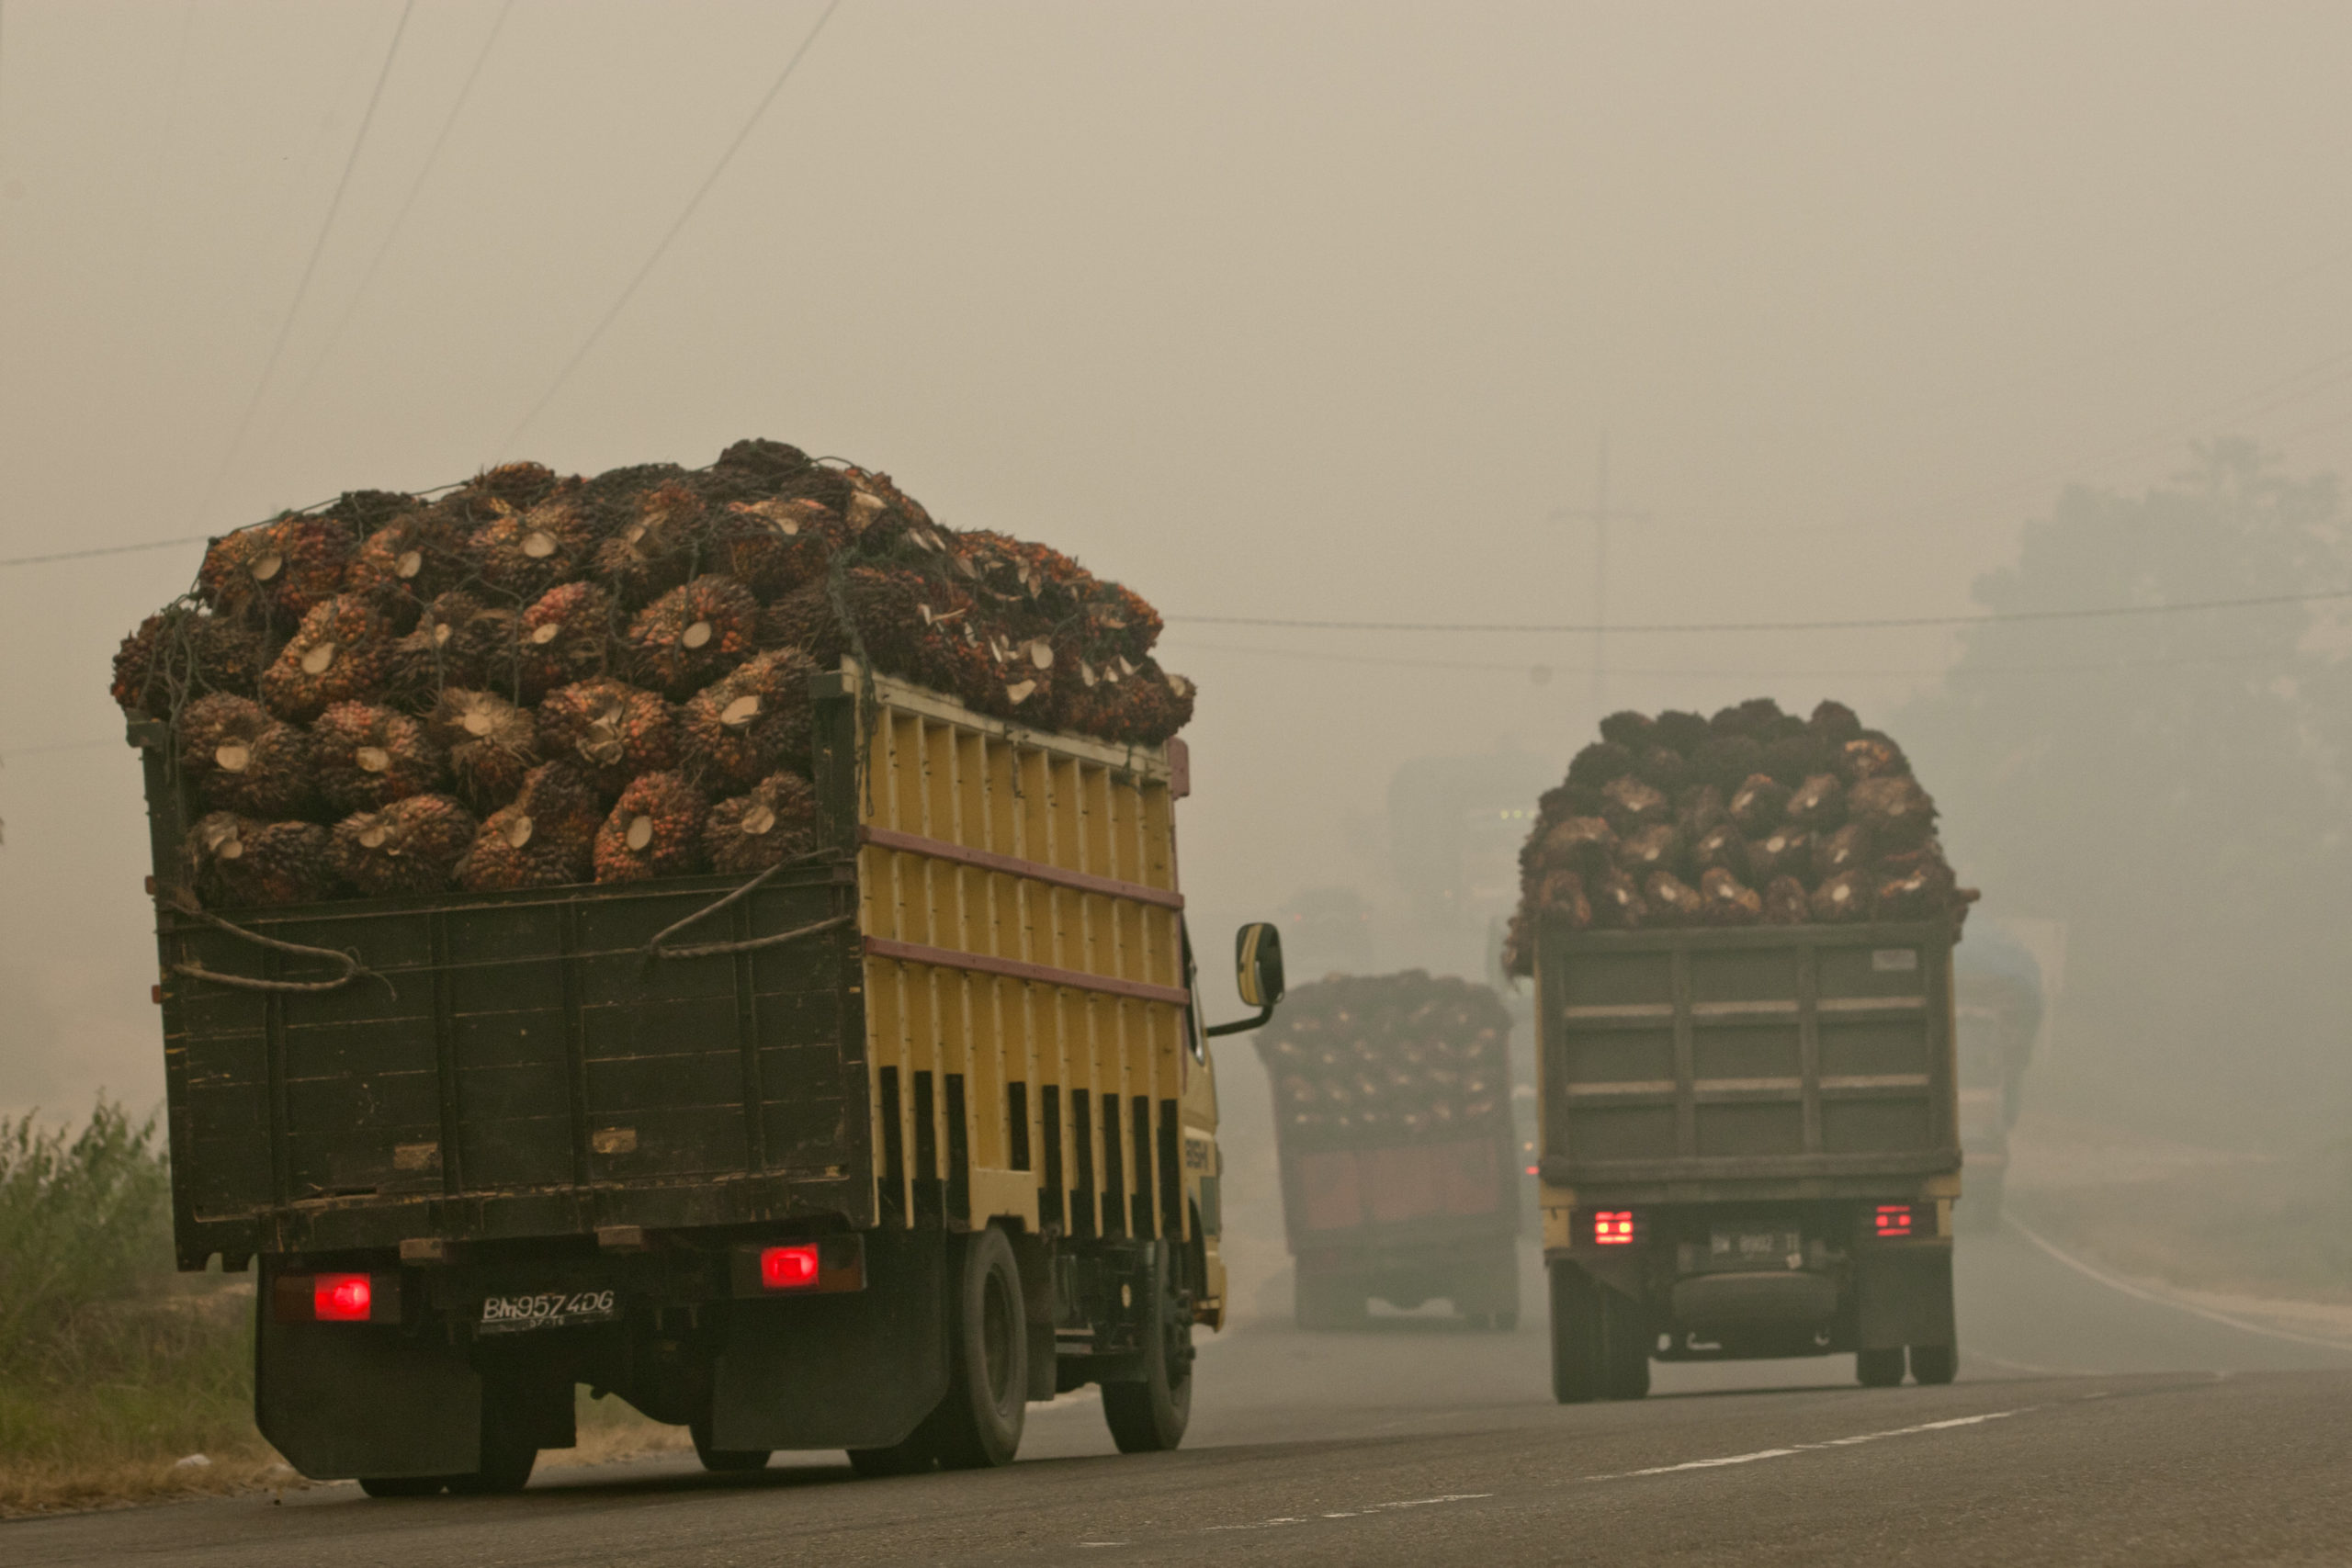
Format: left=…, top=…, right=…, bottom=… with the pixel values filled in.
left=254, top=1316, right=482, bottom=1481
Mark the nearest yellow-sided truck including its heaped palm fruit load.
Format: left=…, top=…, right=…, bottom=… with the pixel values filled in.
left=115, top=442, right=1282, bottom=1495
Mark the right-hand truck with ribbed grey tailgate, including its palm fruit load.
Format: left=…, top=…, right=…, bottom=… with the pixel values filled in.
left=1505, top=698, right=1975, bottom=1401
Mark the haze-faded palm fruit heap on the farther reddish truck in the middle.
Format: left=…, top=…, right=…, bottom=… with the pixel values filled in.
left=1259, top=968, right=1510, bottom=1145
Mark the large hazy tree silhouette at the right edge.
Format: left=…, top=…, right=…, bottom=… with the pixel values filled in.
left=1895, top=442, right=2352, bottom=1140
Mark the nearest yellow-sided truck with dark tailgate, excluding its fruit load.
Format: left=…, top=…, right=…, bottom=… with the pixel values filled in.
left=131, top=660, right=1282, bottom=1495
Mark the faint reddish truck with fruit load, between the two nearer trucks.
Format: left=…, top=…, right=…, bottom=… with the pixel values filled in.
left=1256, top=968, right=1520, bottom=1328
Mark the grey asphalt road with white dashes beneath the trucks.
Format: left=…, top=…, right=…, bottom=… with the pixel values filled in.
left=18, top=1232, right=2352, bottom=1568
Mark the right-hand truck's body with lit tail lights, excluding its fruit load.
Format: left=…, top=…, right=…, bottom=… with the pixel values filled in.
left=1536, top=921, right=1962, bottom=1401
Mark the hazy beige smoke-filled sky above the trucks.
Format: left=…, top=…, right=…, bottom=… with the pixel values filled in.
left=0, top=0, right=2352, bottom=1107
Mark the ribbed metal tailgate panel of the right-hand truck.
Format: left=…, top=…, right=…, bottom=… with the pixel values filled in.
left=1538, top=921, right=1959, bottom=1206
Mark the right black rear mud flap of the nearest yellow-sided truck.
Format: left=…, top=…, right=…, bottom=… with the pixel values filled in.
left=710, top=1229, right=948, bottom=1450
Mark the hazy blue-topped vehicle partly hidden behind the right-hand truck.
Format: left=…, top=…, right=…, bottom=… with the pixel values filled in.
left=1952, top=921, right=2044, bottom=1235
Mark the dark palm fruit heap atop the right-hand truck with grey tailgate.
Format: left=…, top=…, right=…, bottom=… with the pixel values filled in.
left=1503, top=696, right=1975, bottom=976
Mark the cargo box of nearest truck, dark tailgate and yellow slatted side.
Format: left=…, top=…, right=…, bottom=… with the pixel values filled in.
left=131, top=668, right=1190, bottom=1267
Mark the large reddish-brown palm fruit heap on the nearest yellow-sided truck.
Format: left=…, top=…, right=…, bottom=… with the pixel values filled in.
left=113, top=440, right=1193, bottom=905
